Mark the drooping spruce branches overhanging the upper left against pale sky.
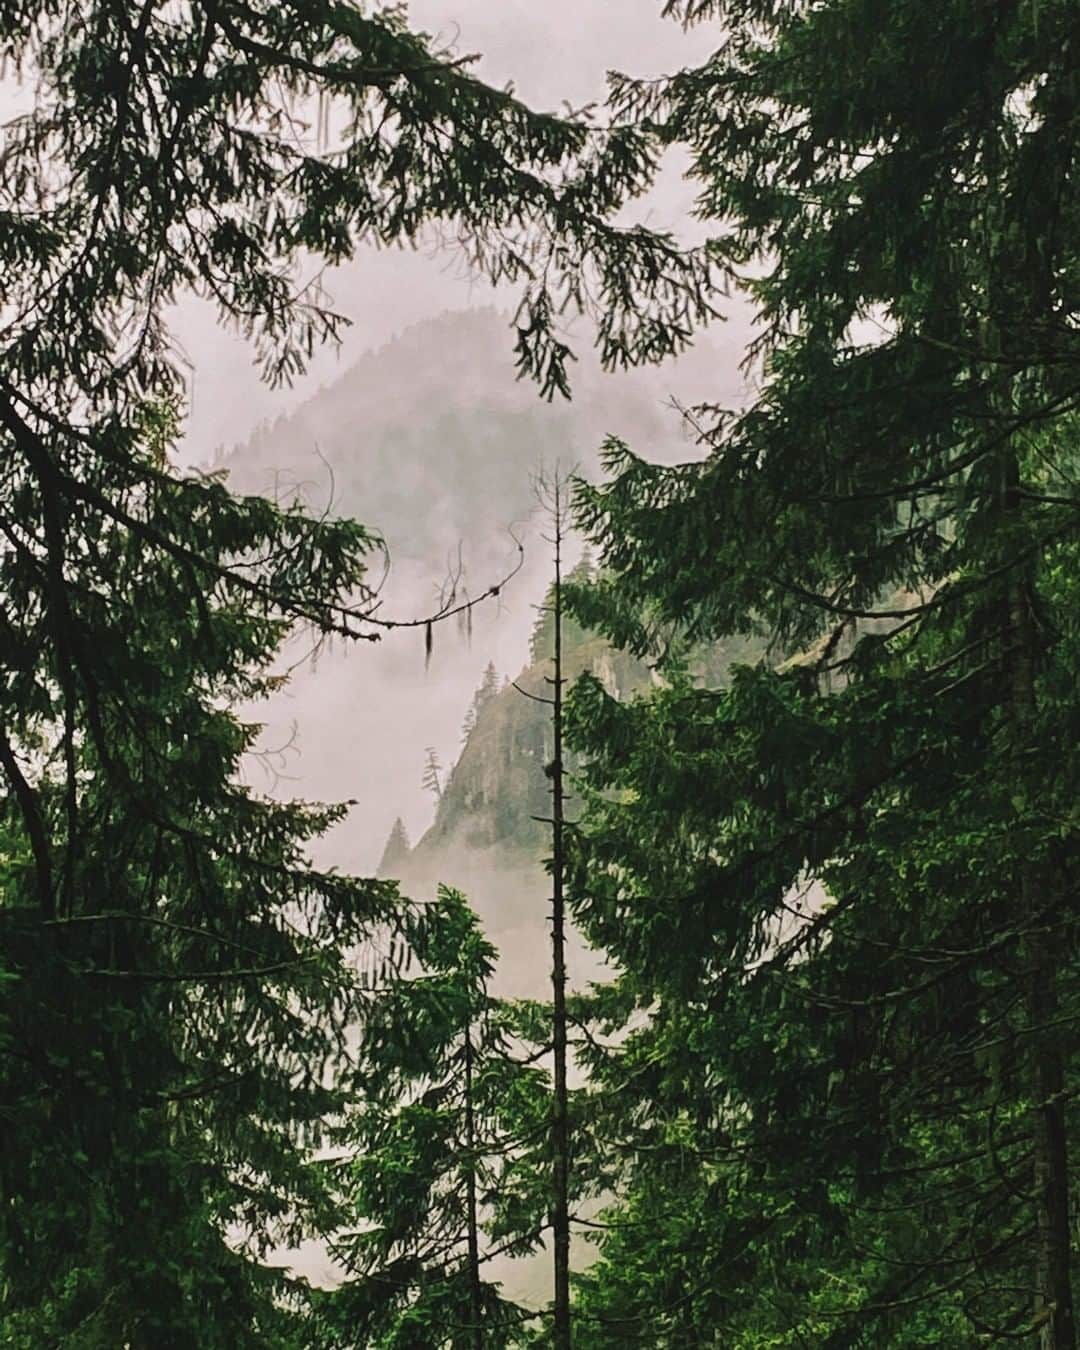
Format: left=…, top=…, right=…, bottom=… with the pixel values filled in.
left=0, top=0, right=709, bottom=405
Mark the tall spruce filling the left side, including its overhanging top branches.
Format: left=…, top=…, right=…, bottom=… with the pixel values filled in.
left=0, top=0, right=710, bottom=1347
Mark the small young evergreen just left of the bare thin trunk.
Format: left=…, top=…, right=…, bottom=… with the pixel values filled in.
left=320, top=887, right=548, bottom=1350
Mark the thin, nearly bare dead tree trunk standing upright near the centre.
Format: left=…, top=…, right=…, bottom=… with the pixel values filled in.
left=551, top=477, right=571, bottom=1350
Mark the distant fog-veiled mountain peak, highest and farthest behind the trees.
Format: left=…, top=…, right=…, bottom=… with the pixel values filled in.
left=220, top=308, right=734, bottom=577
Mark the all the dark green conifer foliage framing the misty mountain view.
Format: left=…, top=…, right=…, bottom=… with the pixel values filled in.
left=0, top=0, right=1080, bottom=1350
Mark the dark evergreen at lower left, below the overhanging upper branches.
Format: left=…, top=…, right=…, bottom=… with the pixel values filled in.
left=0, top=402, right=396, bottom=1350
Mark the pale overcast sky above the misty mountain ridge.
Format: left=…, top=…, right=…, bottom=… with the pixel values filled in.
left=168, top=0, right=711, bottom=462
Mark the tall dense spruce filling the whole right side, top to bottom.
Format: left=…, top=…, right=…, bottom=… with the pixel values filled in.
left=561, top=0, right=1080, bottom=1350
